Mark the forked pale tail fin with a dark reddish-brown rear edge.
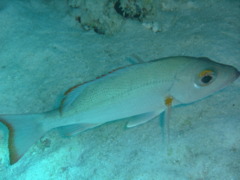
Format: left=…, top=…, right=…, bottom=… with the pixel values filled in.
left=0, top=114, right=45, bottom=164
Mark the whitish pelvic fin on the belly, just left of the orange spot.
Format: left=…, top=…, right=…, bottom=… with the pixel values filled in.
left=127, top=111, right=160, bottom=128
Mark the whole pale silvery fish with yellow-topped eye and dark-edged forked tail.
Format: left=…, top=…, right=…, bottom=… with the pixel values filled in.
left=0, top=56, right=240, bottom=165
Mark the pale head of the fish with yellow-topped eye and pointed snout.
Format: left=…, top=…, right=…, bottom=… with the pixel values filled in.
left=170, top=58, right=240, bottom=104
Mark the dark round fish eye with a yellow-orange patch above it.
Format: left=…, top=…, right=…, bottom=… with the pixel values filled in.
left=195, top=70, right=216, bottom=86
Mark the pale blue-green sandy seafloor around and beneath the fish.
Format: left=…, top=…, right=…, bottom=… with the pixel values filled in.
left=0, top=0, right=240, bottom=180
